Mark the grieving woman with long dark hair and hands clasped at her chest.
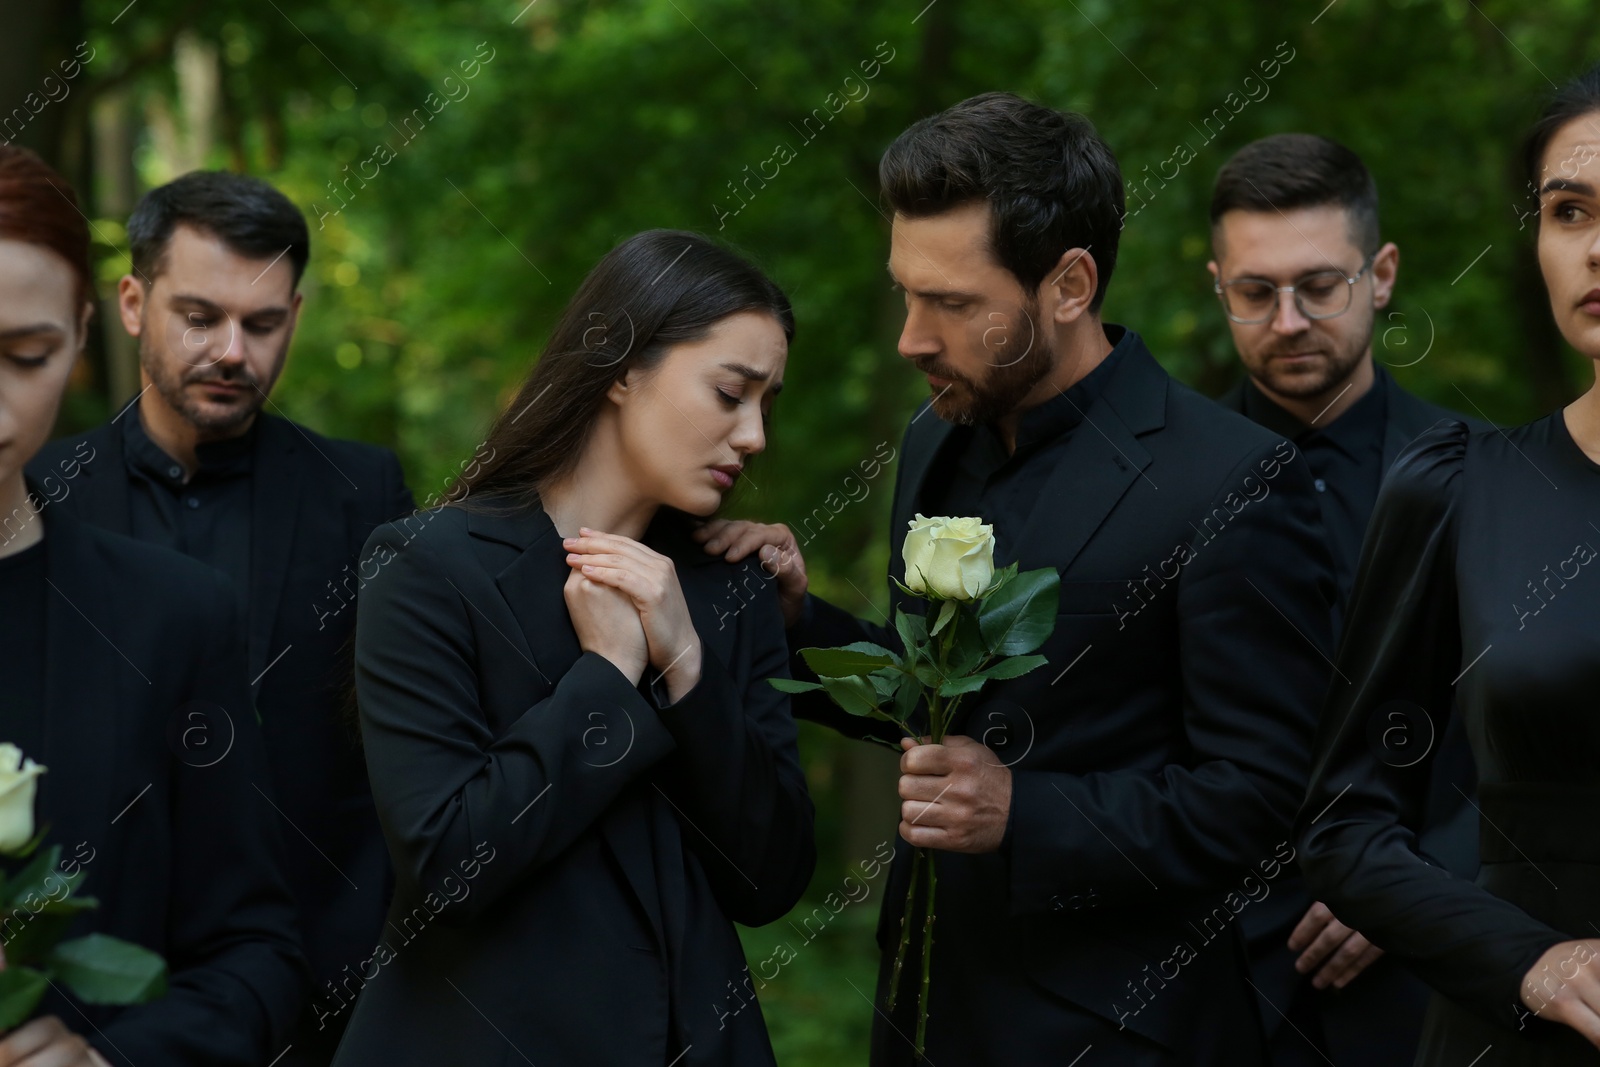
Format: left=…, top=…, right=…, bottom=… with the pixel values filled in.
left=326, top=230, right=816, bottom=1067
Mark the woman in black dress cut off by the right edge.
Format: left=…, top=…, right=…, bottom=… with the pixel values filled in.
left=1299, top=67, right=1600, bottom=1067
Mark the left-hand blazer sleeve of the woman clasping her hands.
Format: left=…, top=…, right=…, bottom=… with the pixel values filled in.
left=355, top=518, right=674, bottom=923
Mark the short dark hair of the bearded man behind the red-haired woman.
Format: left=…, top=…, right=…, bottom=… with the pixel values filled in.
left=128, top=171, right=310, bottom=286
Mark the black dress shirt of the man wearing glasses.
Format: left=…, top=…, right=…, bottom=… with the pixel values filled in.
left=1245, top=374, right=1389, bottom=617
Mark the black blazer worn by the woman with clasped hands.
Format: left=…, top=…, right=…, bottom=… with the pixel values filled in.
left=334, top=507, right=816, bottom=1067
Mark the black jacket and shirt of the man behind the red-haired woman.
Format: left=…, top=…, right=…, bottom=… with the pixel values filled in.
left=29, top=408, right=411, bottom=1067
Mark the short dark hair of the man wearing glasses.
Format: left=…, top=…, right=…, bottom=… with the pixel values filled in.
left=1211, top=133, right=1379, bottom=256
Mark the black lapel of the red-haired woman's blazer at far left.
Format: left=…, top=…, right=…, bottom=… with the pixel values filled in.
left=38, top=510, right=120, bottom=845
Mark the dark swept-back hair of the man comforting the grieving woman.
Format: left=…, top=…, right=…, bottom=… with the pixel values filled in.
left=878, top=93, right=1125, bottom=312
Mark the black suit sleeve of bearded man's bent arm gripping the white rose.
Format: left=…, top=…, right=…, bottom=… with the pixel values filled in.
left=1005, top=442, right=1333, bottom=913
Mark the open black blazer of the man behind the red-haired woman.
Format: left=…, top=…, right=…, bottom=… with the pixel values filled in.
left=29, top=410, right=411, bottom=1017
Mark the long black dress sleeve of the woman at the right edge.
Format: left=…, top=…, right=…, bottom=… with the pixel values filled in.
left=1296, top=421, right=1568, bottom=1025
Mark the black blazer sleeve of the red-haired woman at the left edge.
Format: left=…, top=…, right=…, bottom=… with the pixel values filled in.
left=92, top=574, right=310, bottom=1067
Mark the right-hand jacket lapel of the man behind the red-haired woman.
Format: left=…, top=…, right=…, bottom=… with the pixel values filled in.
left=250, top=413, right=302, bottom=678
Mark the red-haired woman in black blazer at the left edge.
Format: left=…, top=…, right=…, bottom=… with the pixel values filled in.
left=0, top=144, right=310, bottom=1067
